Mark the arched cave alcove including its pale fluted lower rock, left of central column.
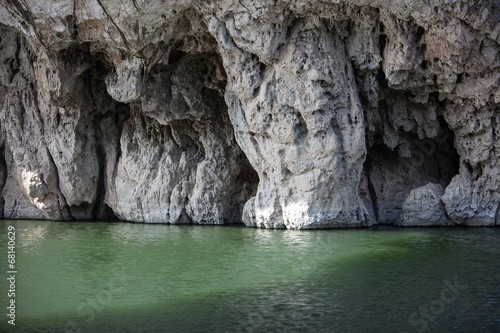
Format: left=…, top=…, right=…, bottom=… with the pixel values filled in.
left=99, top=13, right=259, bottom=224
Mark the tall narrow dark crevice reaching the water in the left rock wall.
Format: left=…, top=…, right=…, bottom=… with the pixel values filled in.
left=57, top=42, right=121, bottom=220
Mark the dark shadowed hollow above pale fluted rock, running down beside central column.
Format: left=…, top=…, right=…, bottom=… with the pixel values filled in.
left=142, top=48, right=259, bottom=223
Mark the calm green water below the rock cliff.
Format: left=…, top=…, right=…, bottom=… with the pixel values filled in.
left=0, top=221, right=500, bottom=332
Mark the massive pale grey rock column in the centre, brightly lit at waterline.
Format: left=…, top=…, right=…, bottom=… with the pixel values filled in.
left=209, top=18, right=370, bottom=229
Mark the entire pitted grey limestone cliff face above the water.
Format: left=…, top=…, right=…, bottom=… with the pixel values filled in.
left=0, top=0, right=500, bottom=229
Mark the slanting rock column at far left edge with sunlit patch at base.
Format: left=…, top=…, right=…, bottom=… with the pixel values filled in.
left=0, top=27, right=69, bottom=220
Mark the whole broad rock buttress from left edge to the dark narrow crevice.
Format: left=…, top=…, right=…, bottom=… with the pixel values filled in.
left=0, top=28, right=110, bottom=220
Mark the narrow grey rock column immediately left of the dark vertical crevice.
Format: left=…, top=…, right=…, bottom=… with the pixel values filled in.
left=34, top=47, right=99, bottom=219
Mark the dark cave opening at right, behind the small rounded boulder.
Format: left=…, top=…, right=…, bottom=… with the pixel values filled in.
left=360, top=109, right=460, bottom=224
